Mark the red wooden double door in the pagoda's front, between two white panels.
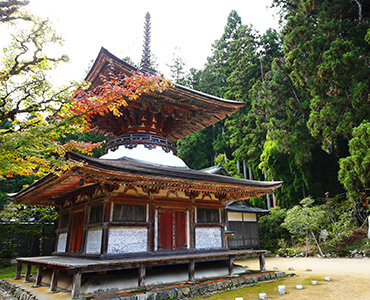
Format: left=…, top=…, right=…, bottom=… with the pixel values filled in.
left=159, top=209, right=187, bottom=250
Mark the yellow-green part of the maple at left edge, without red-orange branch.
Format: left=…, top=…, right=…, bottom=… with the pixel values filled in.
left=0, top=10, right=87, bottom=179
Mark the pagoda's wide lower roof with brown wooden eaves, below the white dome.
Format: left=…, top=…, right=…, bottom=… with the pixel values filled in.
left=11, top=152, right=282, bottom=204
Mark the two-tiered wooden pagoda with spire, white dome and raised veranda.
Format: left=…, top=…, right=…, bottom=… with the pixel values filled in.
left=12, top=13, right=282, bottom=299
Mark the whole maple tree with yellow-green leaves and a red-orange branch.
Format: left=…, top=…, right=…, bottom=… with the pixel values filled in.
left=0, top=10, right=168, bottom=179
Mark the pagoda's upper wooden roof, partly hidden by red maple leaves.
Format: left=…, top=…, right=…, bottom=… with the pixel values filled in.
left=85, top=48, right=244, bottom=142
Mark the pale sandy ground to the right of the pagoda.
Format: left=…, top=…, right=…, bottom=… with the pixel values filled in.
left=234, top=258, right=370, bottom=300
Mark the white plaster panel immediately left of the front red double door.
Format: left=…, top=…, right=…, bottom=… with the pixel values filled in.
left=107, top=228, right=148, bottom=254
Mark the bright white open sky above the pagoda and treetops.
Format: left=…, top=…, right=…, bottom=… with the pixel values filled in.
left=18, top=0, right=278, bottom=84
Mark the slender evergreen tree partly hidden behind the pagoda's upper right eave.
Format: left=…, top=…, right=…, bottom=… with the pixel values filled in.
left=177, top=10, right=242, bottom=169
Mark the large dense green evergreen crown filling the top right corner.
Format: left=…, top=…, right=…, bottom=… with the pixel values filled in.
left=283, top=0, right=370, bottom=152
